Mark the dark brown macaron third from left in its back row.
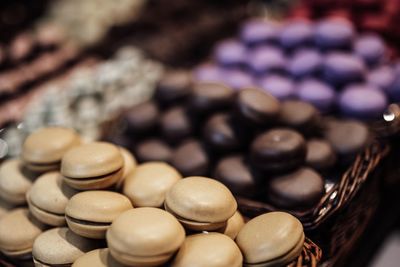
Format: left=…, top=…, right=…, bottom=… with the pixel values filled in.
left=235, top=88, right=280, bottom=125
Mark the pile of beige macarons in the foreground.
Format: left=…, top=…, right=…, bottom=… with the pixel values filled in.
left=0, top=127, right=305, bottom=267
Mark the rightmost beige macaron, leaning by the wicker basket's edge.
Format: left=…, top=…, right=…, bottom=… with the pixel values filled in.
left=236, top=212, right=305, bottom=267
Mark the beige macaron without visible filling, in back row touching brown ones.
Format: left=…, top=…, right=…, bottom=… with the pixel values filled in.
left=123, top=161, right=182, bottom=208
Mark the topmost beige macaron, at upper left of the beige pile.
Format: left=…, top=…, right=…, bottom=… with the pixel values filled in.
left=21, top=127, right=80, bottom=172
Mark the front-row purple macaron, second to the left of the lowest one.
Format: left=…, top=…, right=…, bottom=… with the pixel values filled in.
left=258, top=74, right=295, bottom=100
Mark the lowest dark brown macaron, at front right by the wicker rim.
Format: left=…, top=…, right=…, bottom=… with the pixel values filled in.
left=268, top=168, right=325, bottom=210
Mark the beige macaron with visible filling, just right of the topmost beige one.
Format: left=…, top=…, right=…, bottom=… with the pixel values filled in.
left=61, top=142, right=124, bottom=190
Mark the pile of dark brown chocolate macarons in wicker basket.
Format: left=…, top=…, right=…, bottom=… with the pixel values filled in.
left=107, top=70, right=371, bottom=211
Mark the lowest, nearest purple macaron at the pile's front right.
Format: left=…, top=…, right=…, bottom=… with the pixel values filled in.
left=339, top=84, right=388, bottom=120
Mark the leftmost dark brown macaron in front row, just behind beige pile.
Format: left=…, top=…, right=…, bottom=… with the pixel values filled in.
left=135, top=139, right=173, bottom=162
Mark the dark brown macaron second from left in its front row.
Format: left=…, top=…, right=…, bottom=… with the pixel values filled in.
left=171, top=139, right=210, bottom=177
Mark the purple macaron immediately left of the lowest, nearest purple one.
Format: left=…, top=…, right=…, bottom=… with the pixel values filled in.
left=296, top=79, right=336, bottom=113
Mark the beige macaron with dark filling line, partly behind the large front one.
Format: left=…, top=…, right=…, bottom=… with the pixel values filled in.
left=65, top=190, right=133, bottom=239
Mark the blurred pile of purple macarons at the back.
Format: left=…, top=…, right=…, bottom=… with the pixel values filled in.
left=193, top=17, right=400, bottom=120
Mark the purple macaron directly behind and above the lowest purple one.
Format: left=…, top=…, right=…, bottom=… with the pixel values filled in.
left=322, top=52, right=367, bottom=87
